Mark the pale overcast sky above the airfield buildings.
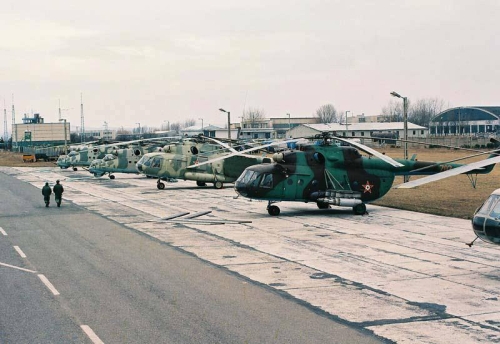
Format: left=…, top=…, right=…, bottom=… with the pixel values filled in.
left=0, top=0, right=500, bottom=136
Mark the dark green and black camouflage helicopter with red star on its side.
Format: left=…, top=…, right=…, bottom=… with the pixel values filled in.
left=225, top=133, right=500, bottom=216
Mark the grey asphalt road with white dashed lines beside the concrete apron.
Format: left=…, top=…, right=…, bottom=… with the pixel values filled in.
left=0, top=173, right=382, bottom=344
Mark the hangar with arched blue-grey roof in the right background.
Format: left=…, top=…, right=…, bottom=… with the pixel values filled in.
left=429, top=106, right=500, bottom=135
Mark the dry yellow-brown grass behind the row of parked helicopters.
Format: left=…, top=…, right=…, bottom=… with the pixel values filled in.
left=0, top=148, right=500, bottom=219
